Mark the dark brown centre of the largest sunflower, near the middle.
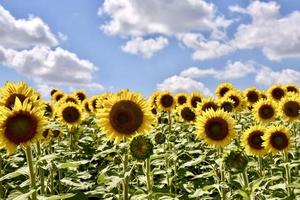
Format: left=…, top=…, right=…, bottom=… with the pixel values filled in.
left=109, top=100, right=144, bottom=134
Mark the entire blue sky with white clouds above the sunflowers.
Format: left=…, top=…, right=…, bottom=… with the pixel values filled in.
left=0, top=0, right=300, bottom=95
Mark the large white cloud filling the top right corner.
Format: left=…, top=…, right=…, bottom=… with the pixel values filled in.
left=231, top=1, right=300, bottom=60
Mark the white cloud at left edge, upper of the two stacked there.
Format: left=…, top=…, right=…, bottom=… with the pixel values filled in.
left=0, top=5, right=58, bottom=48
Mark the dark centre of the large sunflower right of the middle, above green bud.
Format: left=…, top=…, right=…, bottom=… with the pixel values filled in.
left=205, top=117, right=229, bottom=141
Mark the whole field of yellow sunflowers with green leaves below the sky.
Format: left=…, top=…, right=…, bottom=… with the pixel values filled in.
left=0, top=81, right=300, bottom=200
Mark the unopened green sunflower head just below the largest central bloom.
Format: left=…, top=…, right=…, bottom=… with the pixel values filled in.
left=130, top=135, right=153, bottom=160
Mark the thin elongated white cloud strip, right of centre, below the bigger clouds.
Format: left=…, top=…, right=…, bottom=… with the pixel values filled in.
left=180, top=61, right=256, bottom=80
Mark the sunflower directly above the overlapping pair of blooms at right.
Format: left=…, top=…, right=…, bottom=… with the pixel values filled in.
left=252, top=99, right=276, bottom=123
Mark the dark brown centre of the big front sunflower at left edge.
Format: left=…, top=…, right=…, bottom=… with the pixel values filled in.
left=4, top=111, right=38, bottom=144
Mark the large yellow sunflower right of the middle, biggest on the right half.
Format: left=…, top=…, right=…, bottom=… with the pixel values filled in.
left=196, top=109, right=235, bottom=147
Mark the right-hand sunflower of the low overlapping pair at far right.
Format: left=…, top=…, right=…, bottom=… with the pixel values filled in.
left=263, top=126, right=291, bottom=153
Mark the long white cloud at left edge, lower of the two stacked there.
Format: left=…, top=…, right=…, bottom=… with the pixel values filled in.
left=0, top=46, right=101, bottom=85
